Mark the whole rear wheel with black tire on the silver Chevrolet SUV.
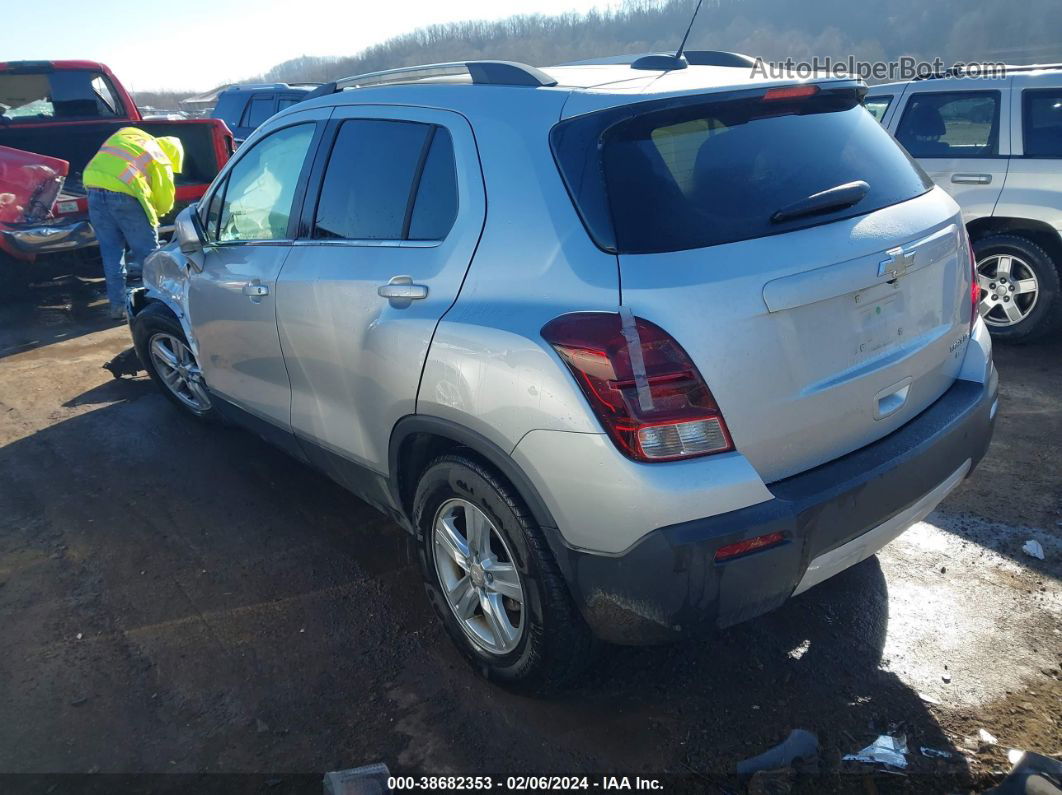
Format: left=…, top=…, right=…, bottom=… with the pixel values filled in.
left=413, top=454, right=596, bottom=693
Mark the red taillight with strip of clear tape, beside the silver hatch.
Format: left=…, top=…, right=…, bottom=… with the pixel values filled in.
left=542, top=312, right=734, bottom=461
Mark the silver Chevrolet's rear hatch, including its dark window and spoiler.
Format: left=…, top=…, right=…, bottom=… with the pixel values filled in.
left=551, top=82, right=972, bottom=482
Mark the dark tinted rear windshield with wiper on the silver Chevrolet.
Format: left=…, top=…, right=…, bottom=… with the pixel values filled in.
left=551, top=84, right=931, bottom=254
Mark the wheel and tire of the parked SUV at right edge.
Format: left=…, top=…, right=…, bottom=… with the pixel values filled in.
left=974, top=235, right=1062, bottom=343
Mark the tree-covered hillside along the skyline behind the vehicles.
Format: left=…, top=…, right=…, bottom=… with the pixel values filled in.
left=256, top=0, right=1062, bottom=82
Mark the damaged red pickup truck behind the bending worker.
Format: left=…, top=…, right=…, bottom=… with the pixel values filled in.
left=0, top=61, right=234, bottom=279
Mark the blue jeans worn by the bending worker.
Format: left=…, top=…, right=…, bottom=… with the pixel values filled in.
left=88, top=188, right=158, bottom=311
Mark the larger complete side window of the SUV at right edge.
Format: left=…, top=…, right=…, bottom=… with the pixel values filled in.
left=896, top=91, right=999, bottom=157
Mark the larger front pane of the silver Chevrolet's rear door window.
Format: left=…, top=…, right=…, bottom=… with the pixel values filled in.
left=313, top=119, right=432, bottom=240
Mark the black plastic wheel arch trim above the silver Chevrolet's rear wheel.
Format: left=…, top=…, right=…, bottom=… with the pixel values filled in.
left=388, top=414, right=556, bottom=535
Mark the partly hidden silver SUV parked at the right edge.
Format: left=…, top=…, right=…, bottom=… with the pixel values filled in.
left=866, top=65, right=1062, bottom=342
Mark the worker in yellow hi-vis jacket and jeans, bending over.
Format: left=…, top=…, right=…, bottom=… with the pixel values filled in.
left=82, top=127, right=185, bottom=321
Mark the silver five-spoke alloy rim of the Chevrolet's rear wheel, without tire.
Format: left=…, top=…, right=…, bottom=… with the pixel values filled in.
left=432, top=499, right=526, bottom=655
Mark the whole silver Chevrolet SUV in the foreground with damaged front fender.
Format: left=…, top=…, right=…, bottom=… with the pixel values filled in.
left=130, top=52, right=997, bottom=688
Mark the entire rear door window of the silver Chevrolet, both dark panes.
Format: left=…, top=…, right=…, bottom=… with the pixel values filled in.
left=313, top=119, right=457, bottom=240
